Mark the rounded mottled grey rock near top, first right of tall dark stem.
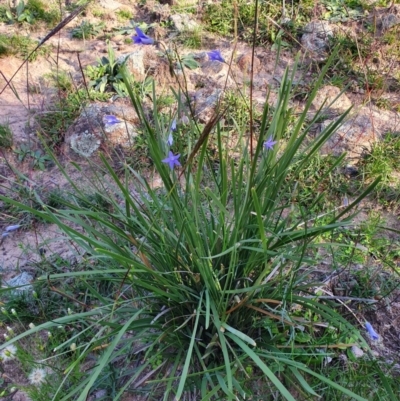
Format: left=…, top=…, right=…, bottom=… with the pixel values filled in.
left=301, top=21, right=334, bottom=60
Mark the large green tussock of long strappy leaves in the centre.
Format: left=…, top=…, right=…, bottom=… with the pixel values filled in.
left=1, top=56, right=384, bottom=401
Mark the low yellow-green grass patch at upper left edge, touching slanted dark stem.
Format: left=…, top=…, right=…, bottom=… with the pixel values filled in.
left=0, top=34, right=50, bottom=61
